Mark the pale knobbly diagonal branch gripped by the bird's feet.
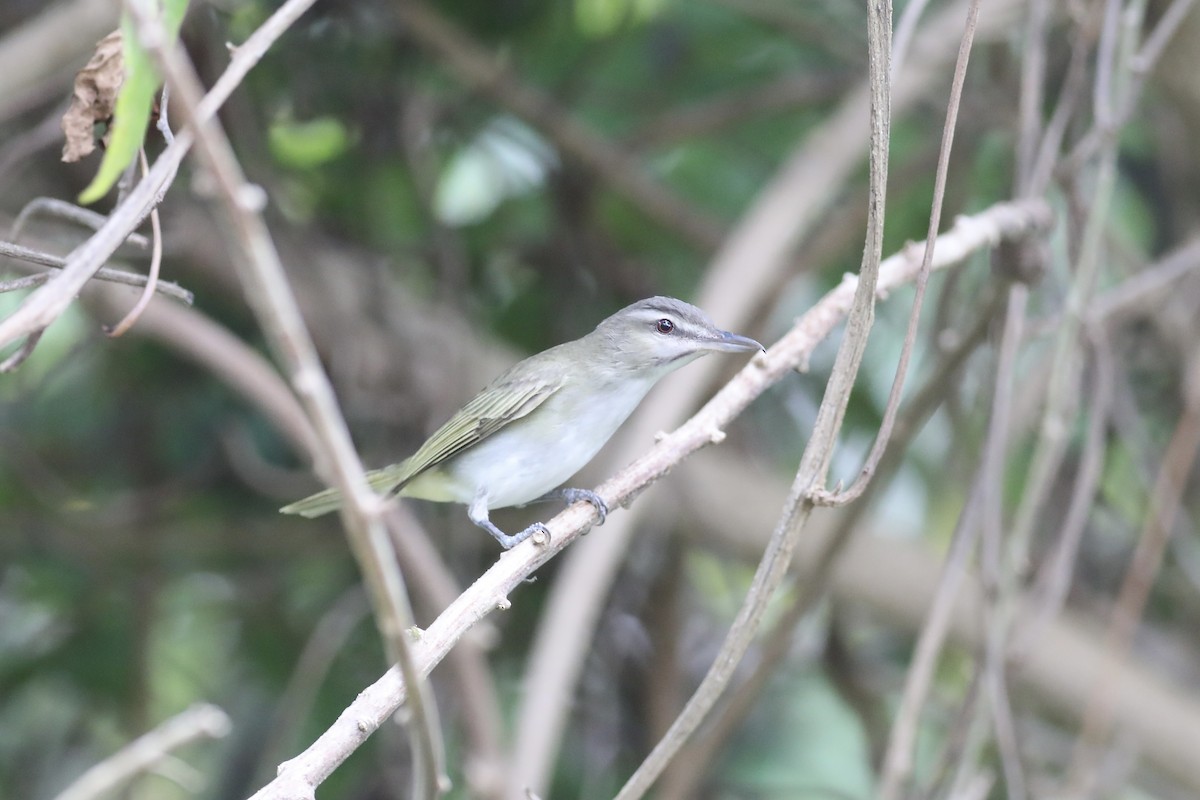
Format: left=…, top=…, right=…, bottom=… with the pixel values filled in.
left=243, top=200, right=1054, bottom=800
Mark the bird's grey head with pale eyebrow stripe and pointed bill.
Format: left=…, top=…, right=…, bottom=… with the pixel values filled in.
left=595, top=297, right=763, bottom=374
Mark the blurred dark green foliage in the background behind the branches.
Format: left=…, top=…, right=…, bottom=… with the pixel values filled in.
left=0, top=0, right=1196, bottom=800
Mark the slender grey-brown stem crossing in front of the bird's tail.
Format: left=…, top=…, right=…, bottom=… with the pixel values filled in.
left=119, top=0, right=449, bottom=798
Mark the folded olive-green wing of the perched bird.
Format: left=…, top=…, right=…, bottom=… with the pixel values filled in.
left=391, top=379, right=563, bottom=491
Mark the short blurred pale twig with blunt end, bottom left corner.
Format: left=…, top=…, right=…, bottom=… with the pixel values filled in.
left=55, top=704, right=230, bottom=800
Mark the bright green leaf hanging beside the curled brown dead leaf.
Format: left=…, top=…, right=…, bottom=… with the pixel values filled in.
left=79, top=0, right=187, bottom=205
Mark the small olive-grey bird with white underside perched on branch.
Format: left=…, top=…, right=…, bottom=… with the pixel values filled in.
left=281, top=297, right=762, bottom=548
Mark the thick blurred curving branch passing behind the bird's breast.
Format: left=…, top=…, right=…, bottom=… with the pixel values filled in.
left=510, top=0, right=1025, bottom=794
